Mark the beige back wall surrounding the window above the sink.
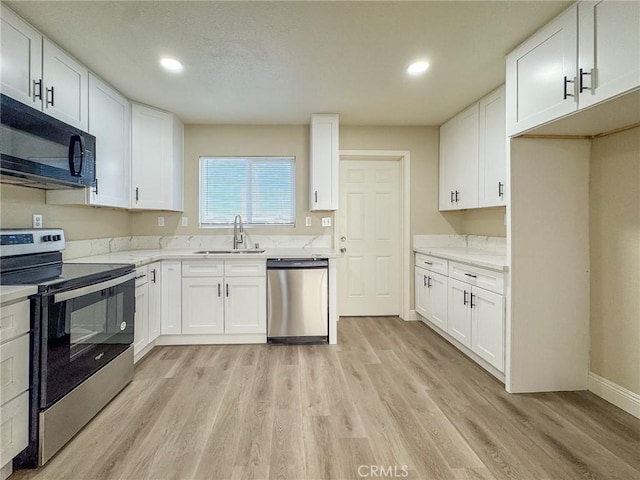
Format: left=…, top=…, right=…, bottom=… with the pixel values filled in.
left=133, top=125, right=333, bottom=235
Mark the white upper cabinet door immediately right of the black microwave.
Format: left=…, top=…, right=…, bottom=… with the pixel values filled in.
left=89, top=74, right=131, bottom=208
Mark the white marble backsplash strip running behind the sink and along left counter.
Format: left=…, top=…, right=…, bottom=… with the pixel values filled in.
left=62, top=232, right=331, bottom=260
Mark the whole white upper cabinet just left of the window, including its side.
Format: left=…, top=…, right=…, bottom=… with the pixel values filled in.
left=131, top=104, right=184, bottom=211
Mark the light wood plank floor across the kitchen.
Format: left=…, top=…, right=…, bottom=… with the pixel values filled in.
left=10, top=317, right=640, bottom=480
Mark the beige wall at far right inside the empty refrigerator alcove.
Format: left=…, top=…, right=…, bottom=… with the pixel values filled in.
left=590, top=128, right=640, bottom=394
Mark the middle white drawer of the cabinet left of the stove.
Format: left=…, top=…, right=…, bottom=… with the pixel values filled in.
left=0, top=335, right=29, bottom=405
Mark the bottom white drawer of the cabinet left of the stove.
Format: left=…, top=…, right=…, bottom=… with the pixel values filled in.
left=0, top=392, right=29, bottom=465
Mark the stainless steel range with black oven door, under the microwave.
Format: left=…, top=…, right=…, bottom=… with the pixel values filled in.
left=0, top=229, right=135, bottom=468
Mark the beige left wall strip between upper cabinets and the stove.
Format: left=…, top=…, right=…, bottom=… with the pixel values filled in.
left=0, top=184, right=131, bottom=240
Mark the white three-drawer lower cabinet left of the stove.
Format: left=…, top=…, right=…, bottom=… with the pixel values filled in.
left=0, top=300, right=30, bottom=468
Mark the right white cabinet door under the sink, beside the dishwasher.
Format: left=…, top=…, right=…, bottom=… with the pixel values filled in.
left=224, top=277, right=267, bottom=333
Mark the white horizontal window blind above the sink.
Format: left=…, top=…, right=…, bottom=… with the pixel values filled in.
left=200, top=157, right=296, bottom=227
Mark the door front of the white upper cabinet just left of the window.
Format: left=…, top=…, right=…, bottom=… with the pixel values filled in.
left=131, top=104, right=172, bottom=210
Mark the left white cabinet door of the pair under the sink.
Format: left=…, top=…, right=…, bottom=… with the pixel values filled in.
left=182, top=277, right=224, bottom=334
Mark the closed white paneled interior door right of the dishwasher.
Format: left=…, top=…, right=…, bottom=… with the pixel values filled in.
left=338, top=160, right=402, bottom=316
